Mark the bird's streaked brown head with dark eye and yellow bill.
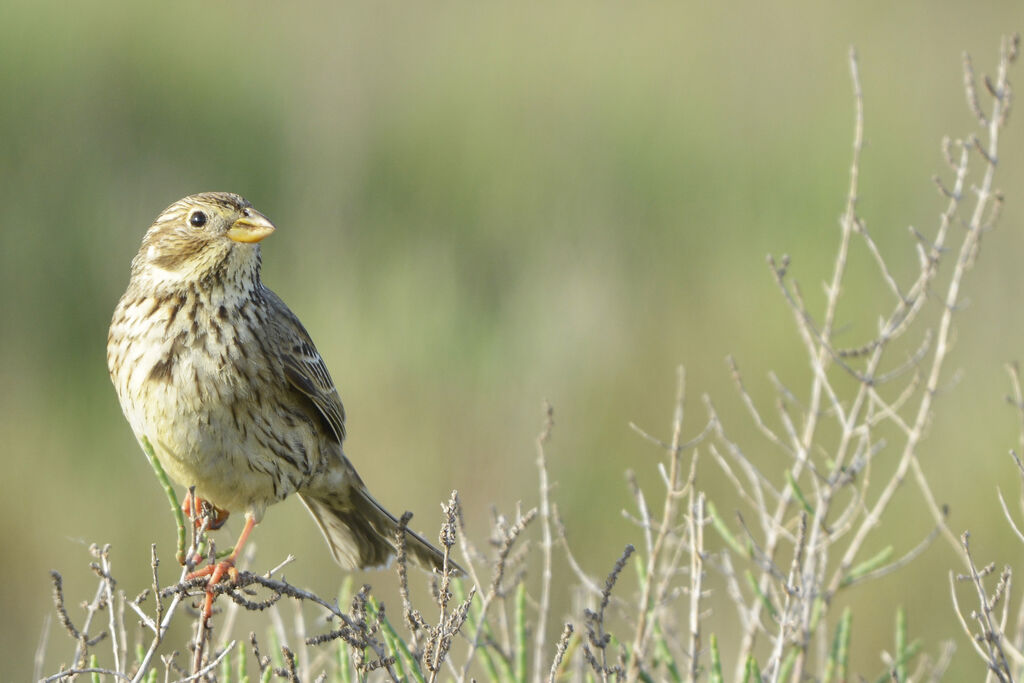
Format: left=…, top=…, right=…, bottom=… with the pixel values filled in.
left=132, top=193, right=274, bottom=287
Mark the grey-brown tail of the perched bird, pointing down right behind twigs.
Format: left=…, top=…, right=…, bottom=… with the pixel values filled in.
left=299, top=486, right=463, bottom=575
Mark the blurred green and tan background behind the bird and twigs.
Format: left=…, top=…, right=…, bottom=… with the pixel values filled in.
left=0, top=0, right=1024, bottom=680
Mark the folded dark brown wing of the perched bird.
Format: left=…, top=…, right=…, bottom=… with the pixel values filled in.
left=263, top=288, right=345, bottom=443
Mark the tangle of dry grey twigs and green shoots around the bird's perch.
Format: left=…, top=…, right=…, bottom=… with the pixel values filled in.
left=37, top=37, right=1024, bottom=682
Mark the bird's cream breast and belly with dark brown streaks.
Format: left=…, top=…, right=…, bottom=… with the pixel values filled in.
left=108, top=286, right=324, bottom=510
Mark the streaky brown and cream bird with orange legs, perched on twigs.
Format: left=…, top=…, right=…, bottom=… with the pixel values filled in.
left=106, top=191, right=462, bottom=612
